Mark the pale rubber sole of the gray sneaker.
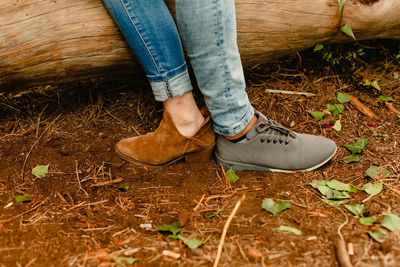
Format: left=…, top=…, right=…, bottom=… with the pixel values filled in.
left=215, top=147, right=337, bottom=173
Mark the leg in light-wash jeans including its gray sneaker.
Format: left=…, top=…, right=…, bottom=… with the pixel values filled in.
left=176, top=0, right=336, bottom=171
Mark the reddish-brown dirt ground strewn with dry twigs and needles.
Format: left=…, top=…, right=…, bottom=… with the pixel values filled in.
left=0, top=41, right=400, bottom=266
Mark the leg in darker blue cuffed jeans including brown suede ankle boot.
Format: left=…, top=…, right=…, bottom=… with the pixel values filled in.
left=103, top=0, right=214, bottom=165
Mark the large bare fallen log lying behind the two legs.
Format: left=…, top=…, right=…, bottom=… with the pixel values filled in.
left=0, top=0, right=400, bottom=92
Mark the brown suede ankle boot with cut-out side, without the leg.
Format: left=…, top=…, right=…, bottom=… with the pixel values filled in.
left=115, top=111, right=215, bottom=166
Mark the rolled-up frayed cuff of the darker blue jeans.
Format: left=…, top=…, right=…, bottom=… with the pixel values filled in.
left=147, top=65, right=193, bottom=101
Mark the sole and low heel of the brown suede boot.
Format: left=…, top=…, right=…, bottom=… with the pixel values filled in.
left=115, top=147, right=214, bottom=167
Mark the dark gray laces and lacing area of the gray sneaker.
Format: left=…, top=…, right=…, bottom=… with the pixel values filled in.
left=256, top=119, right=296, bottom=145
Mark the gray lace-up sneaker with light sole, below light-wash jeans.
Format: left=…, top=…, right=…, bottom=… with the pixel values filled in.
left=215, top=111, right=337, bottom=172
